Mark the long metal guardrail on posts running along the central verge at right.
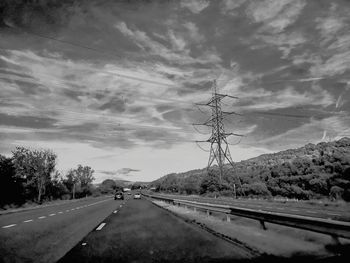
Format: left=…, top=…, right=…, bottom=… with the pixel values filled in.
left=143, top=193, right=350, bottom=241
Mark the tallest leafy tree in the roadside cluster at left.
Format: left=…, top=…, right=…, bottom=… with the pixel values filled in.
left=12, top=147, right=57, bottom=203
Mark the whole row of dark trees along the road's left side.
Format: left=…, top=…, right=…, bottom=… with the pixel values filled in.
left=0, top=147, right=96, bottom=208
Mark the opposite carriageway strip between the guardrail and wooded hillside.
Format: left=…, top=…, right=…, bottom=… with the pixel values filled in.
left=152, top=194, right=350, bottom=221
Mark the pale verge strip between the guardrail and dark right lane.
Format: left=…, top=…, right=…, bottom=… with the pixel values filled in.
left=154, top=201, right=350, bottom=259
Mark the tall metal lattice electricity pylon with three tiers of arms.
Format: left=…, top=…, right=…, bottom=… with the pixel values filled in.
left=193, top=80, right=243, bottom=193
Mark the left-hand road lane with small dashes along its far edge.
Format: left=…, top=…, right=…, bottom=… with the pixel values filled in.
left=0, top=197, right=122, bottom=263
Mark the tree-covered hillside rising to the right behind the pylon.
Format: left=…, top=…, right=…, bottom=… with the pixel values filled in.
left=150, top=137, right=350, bottom=201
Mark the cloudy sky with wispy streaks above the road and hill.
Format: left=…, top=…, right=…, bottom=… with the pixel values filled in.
left=0, top=0, right=350, bottom=183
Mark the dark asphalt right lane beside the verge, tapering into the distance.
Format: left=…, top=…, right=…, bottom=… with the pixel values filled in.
left=59, top=199, right=251, bottom=263
